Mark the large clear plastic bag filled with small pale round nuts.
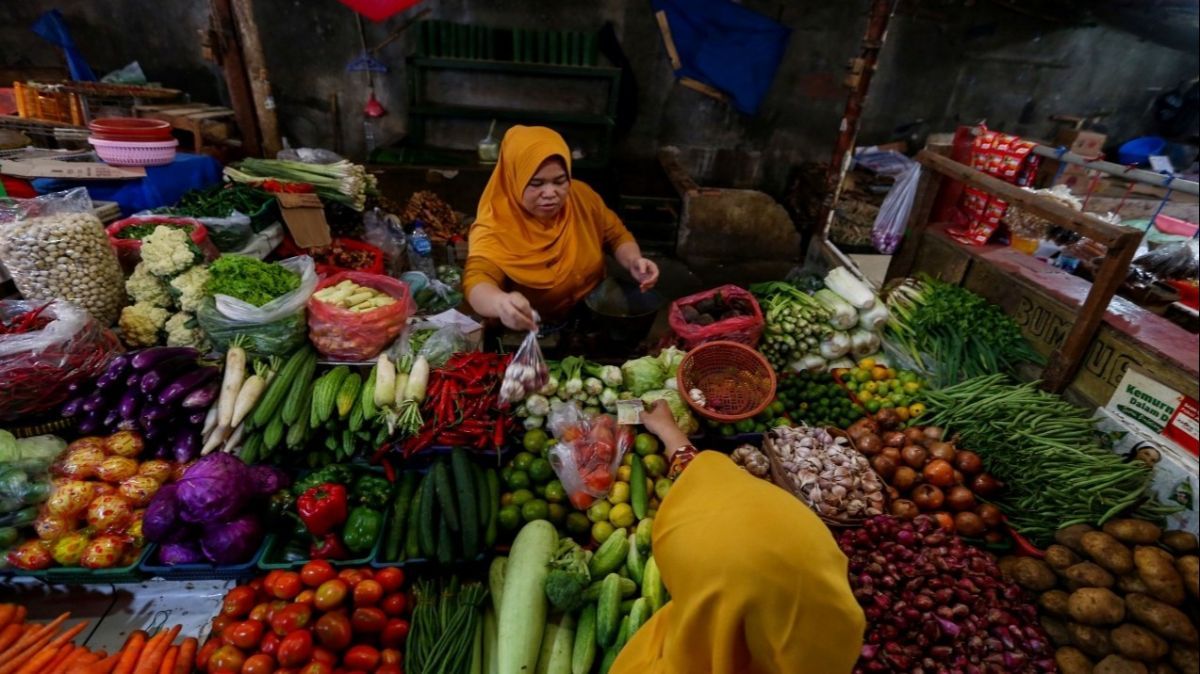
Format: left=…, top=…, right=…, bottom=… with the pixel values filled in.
left=0, top=187, right=126, bottom=326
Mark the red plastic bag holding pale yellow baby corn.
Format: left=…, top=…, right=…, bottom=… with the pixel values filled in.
left=308, top=271, right=416, bottom=361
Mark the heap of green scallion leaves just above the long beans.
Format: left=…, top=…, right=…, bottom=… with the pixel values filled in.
left=887, top=278, right=1044, bottom=386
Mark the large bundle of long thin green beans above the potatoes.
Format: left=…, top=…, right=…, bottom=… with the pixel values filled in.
left=926, top=374, right=1174, bottom=544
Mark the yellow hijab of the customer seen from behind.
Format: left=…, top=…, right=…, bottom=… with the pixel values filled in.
left=611, top=452, right=865, bottom=674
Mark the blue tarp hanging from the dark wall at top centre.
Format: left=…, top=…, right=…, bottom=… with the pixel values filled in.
left=652, top=0, right=791, bottom=115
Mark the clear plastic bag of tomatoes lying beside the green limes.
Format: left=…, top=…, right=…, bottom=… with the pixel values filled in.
left=547, top=403, right=634, bottom=510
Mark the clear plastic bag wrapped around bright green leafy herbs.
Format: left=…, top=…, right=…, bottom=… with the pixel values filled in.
left=196, top=255, right=317, bottom=356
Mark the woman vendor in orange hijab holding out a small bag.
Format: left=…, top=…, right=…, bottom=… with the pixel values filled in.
left=463, top=126, right=659, bottom=330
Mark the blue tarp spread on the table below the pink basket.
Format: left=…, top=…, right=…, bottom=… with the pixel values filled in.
left=34, top=152, right=221, bottom=216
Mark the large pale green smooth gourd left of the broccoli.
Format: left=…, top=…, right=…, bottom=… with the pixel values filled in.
left=497, top=519, right=558, bottom=674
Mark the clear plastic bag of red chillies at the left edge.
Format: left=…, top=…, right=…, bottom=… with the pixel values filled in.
left=0, top=300, right=121, bottom=421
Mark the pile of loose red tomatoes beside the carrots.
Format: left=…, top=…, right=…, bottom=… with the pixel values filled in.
left=197, top=560, right=412, bottom=674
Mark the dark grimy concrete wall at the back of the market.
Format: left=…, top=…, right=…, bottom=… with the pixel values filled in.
left=0, top=0, right=1198, bottom=194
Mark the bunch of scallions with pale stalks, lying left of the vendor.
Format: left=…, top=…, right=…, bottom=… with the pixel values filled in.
left=224, top=157, right=378, bottom=211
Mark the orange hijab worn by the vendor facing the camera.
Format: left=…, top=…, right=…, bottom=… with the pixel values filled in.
left=470, top=126, right=605, bottom=289
